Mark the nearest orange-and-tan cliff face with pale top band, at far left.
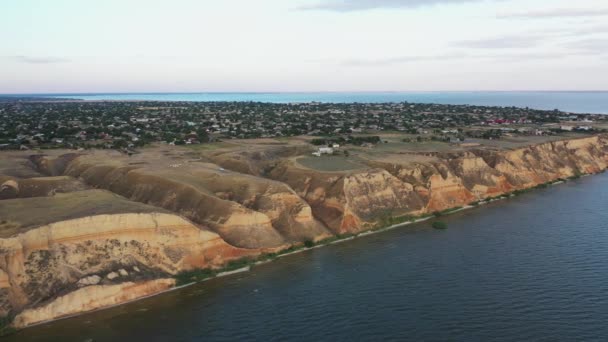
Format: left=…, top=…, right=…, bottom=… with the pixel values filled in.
left=0, top=213, right=255, bottom=326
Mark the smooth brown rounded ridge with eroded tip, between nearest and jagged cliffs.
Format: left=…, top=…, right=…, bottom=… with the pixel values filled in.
left=53, top=156, right=329, bottom=248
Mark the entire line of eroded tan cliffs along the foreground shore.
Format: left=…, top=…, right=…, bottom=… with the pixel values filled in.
left=0, top=136, right=608, bottom=327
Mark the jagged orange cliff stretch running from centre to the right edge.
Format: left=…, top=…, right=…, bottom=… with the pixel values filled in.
left=270, top=136, right=608, bottom=233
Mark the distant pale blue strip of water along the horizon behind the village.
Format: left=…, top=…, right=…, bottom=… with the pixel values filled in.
left=2, top=91, right=608, bottom=114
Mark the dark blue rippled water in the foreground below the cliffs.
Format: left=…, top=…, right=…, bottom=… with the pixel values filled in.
left=8, top=174, right=608, bottom=341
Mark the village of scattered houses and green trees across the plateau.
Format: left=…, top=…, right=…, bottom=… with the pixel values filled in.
left=0, top=99, right=608, bottom=152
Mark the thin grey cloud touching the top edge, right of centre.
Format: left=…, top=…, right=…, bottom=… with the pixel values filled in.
left=299, top=0, right=494, bottom=12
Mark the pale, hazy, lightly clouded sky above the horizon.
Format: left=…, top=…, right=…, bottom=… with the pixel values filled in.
left=0, top=0, right=608, bottom=94
